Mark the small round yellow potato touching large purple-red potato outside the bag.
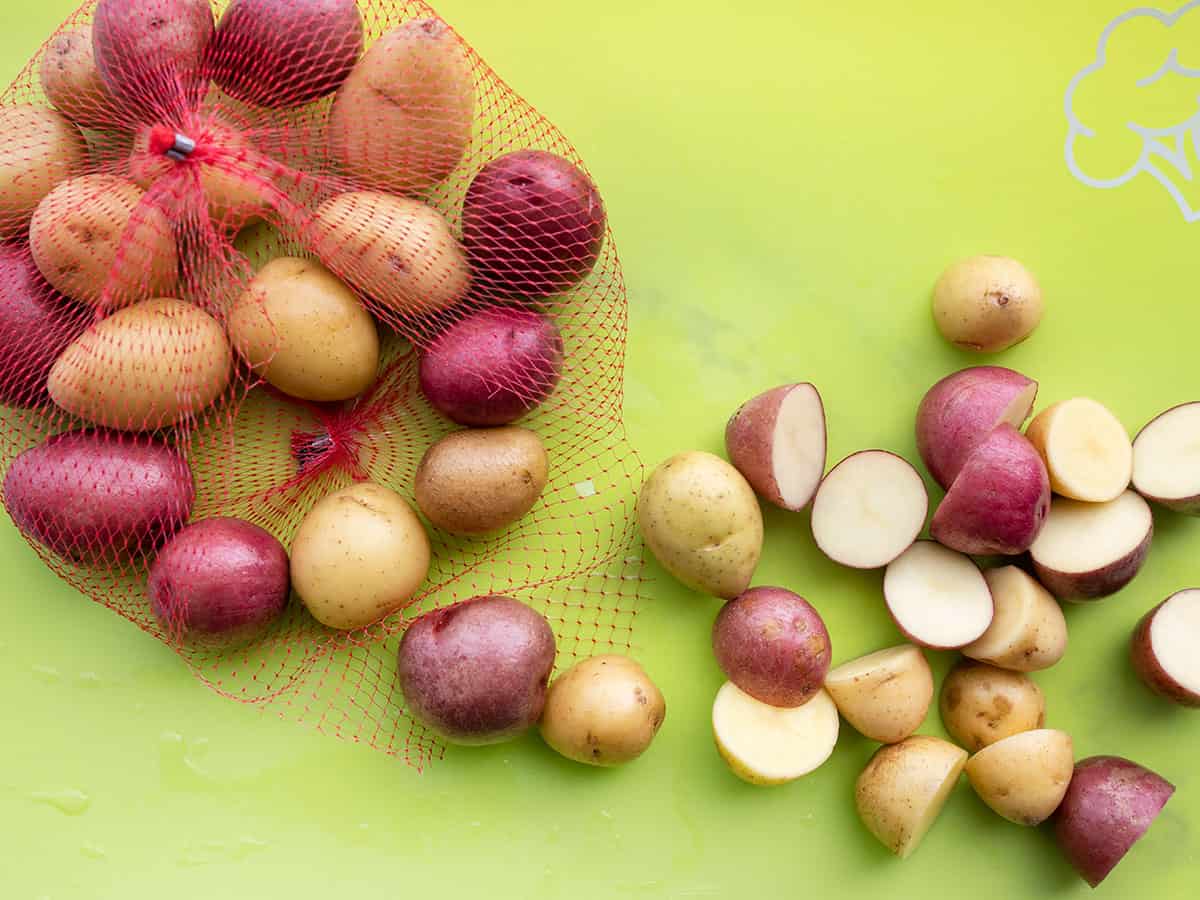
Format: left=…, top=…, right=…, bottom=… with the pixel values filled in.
left=541, top=654, right=667, bottom=766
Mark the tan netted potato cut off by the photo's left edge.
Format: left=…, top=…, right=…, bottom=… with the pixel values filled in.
left=0, top=103, right=88, bottom=241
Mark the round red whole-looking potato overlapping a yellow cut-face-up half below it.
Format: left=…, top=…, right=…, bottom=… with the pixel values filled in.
left=713, top=587, right=833, bottom=707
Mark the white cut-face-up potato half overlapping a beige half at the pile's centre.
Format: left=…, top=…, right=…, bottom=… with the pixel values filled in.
left=883, top=541, right=994, bottom=650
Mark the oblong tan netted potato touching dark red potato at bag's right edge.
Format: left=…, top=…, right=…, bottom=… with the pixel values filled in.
left=312, top=191, right=470, bottom=316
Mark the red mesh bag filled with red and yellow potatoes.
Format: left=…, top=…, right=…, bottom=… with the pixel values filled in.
left=0, top=0, right=641, bottom=766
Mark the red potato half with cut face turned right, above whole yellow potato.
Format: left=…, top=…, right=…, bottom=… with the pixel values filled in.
left=725, top=383, right=826, bottom=511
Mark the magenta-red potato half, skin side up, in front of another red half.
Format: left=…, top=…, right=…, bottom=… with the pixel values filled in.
left=929, top=422, right=1050, bottom=556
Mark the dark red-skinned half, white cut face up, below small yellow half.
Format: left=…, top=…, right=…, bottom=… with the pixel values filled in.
left=1030, top=491, right=1154, bottom=600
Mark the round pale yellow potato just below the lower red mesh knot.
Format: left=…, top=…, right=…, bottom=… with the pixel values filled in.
left=292, top=481, right=431, bottom=630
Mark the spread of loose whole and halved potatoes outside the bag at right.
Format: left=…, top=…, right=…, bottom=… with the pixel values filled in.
left=637, top=257, right=1200, bottom=886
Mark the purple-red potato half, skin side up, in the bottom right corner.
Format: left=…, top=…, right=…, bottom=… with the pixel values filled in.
left=1054, top=756, right=1175, bottom=888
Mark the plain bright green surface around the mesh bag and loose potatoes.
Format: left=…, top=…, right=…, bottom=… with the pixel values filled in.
left=0, top=0, right=1200, bottom=900
